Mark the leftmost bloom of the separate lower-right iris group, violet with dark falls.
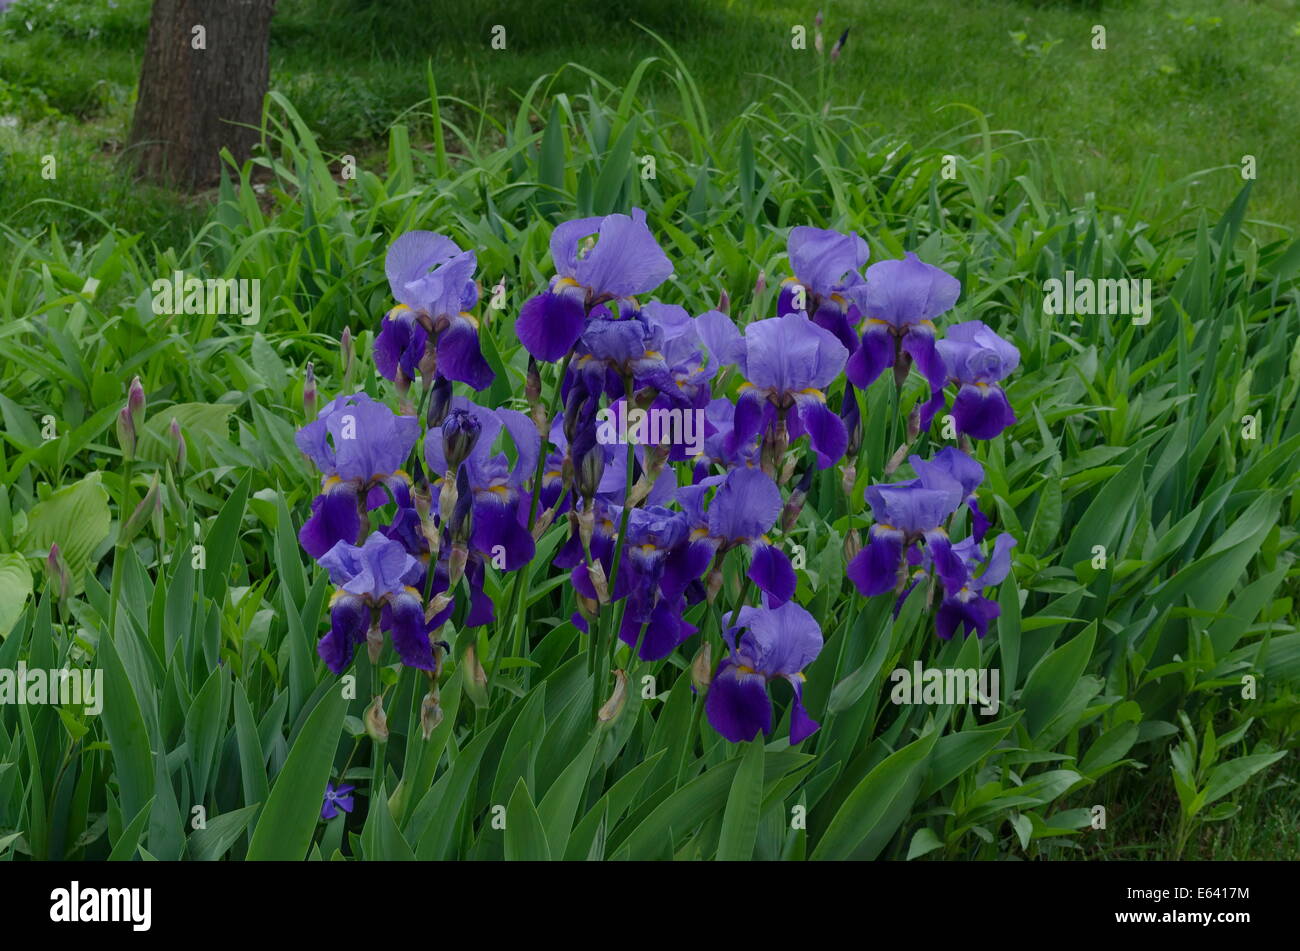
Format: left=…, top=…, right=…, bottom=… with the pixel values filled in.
left=846, top=456, right=967, bottom=598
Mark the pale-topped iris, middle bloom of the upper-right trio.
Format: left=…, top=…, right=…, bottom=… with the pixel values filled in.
left=845, top=251, right=962, bottom=418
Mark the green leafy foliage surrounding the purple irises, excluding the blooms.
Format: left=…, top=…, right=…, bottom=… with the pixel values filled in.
left=0, top=6, right=1300, bottom=859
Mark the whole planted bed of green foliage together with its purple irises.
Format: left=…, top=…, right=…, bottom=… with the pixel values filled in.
left=0, top=3, right=1300, bottom=860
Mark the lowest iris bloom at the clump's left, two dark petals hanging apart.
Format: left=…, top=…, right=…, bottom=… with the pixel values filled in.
left=316, top=531, right=433, bottom=674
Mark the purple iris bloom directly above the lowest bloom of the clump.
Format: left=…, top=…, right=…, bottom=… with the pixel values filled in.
left=668, top=469, right=797, bottom=605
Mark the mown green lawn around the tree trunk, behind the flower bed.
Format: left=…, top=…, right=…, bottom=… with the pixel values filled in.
left=0, top=0, right=1300, bottom=243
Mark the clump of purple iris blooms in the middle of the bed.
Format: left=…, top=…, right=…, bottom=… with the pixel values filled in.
left=298, top=209, right=1019, bottom=753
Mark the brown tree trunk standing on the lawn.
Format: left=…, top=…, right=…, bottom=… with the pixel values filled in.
left=130, top=0, right=276, bottom=191
